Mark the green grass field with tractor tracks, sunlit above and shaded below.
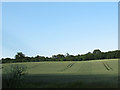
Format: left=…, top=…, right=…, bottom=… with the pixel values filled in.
left=3, top=59, right=119, bottom=88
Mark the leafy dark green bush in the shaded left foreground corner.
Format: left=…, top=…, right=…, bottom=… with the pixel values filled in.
left=3, top=64, right=27, bottom=88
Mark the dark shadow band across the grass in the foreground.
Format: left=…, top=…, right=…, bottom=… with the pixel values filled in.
left=19, top=74, right=118, bottom=88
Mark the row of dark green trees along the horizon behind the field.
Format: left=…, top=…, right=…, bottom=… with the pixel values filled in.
left=0, top=49, right=120, bottom=63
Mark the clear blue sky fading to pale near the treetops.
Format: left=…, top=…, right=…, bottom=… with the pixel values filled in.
left=2, top=2, right=118, bottom=58
